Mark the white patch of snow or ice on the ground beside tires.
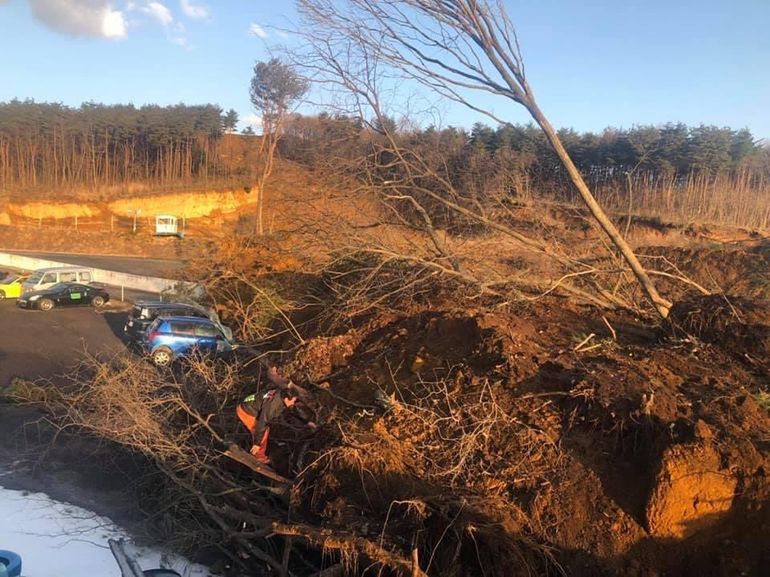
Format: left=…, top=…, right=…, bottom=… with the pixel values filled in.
left=0, top=487, right=209, bottom=577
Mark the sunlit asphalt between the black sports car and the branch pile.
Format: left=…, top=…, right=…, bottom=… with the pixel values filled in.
left=0, top=299, right=126, bottom=387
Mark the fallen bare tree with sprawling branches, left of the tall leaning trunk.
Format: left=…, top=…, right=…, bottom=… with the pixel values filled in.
left=288, top=27, right=631, bottom=308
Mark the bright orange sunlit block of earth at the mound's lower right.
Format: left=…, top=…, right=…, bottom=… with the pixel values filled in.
left=647, top=440, right=738, bottom=539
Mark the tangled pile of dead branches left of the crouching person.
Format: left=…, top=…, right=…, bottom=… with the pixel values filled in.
left=41, top=356, right=308, bottom=575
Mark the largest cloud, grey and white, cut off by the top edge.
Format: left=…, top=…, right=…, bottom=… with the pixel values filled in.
left=29, top=0, right=126, bottom=40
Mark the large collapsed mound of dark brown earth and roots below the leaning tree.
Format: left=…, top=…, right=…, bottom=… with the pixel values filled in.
left=282, top=302, right=770, bottom=576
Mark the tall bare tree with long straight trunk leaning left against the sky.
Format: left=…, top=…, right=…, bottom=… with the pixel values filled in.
left=297, top=0, right=671, bottom=318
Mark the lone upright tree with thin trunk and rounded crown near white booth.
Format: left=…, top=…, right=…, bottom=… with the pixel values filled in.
left=249, top=58, right=308, bottom=236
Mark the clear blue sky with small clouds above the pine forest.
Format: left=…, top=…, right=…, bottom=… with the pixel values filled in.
left=0, top=0, right=770, bottom=141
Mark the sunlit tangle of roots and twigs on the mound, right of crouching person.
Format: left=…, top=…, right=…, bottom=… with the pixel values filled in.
left=296, top=367, right=560, bottom=576
